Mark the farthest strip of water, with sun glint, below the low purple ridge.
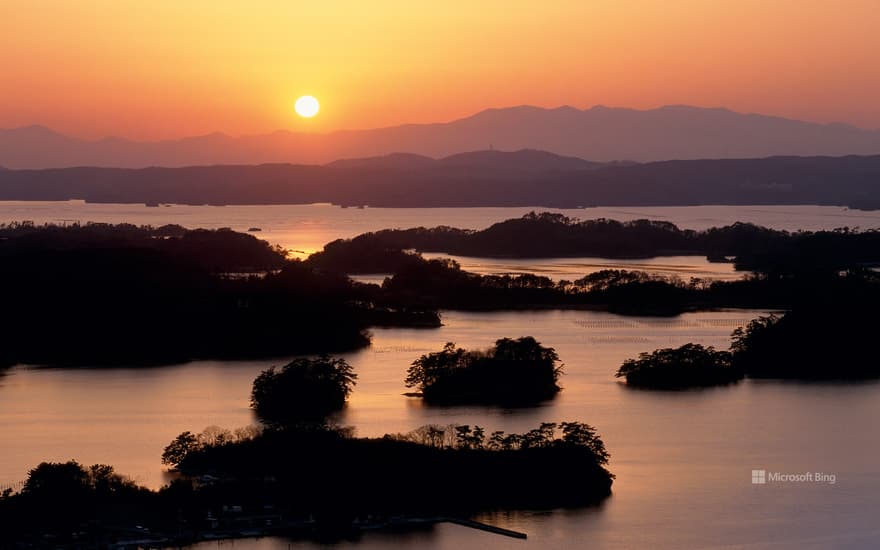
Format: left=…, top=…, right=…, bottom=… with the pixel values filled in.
left=0, top=201, right=880, bottom=256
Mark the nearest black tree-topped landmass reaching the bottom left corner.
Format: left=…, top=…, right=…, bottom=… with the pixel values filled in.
left=0, top=422, right=614, bottom=547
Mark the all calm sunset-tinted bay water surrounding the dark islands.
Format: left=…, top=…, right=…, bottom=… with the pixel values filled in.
left=0, top=203, right=880, bottom=550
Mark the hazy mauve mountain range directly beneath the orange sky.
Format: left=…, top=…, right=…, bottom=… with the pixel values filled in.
left=0, top=106, right=880, bottom=169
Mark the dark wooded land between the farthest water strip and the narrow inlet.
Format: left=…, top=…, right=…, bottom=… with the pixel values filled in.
left=310, top=212, right=880, bottom=273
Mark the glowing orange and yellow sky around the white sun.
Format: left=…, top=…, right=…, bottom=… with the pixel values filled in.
left=0, top=0, right=880, bottom=139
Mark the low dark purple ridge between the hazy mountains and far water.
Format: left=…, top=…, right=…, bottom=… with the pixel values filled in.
left=0, top=150, right=880, bottom=208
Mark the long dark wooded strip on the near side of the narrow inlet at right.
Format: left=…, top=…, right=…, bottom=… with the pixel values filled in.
left=344, top=254, right=880, bottom=316
